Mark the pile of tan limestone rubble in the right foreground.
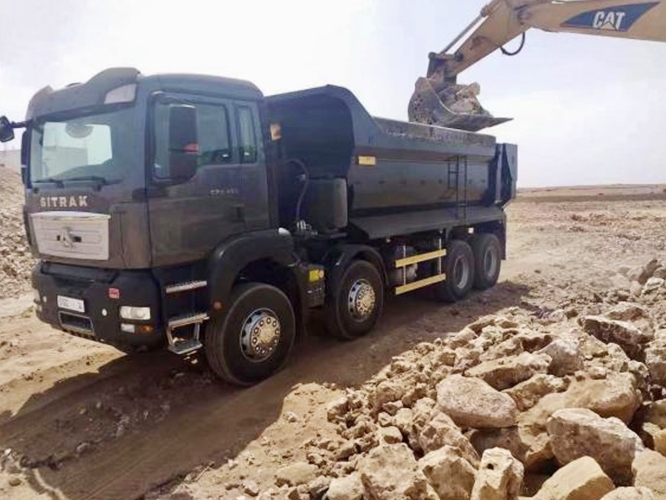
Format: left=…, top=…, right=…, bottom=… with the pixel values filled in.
left=260, top=261, right=666, bottom=500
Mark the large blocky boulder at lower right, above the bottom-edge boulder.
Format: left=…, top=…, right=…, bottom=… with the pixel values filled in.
left=546, top=408, right=645, bottom=485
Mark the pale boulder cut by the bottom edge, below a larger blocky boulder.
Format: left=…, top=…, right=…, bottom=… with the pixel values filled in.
left=532, top=457, right=615, bottom=500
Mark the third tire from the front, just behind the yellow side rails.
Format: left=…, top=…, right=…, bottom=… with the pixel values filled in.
left=433, top=240, right=474, bottom=303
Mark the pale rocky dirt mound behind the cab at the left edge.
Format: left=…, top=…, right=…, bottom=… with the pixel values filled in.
left=0, top=168, right=34, bottom=299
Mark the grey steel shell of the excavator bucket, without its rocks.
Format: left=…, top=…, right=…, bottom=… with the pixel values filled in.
left=408, top=78, right=511, bottom=132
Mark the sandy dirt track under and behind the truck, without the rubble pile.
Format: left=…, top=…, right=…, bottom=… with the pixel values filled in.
left=0, top=188, right=666, bottom=499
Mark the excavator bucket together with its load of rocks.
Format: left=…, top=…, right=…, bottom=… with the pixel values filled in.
left=408, top=78, right=511, bottom=132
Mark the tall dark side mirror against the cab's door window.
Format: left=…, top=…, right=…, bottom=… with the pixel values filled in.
left=169, top=104, right=199, bottom=180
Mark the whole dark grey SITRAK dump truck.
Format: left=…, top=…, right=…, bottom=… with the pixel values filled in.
left=0, top=68, right=516, bottom=384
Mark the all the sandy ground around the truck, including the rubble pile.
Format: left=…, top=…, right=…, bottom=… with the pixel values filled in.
left=0, top=170, right=666, bottom=500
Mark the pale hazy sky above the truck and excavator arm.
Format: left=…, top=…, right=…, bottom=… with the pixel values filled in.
left=0, top=0, right=666, bottom=187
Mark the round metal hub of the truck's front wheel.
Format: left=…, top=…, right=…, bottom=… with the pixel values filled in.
left=240, top=309, right=280, bottom=361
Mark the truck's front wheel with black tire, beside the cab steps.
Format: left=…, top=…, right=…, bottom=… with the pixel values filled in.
left=205, top=283, right=296, bottom=385
